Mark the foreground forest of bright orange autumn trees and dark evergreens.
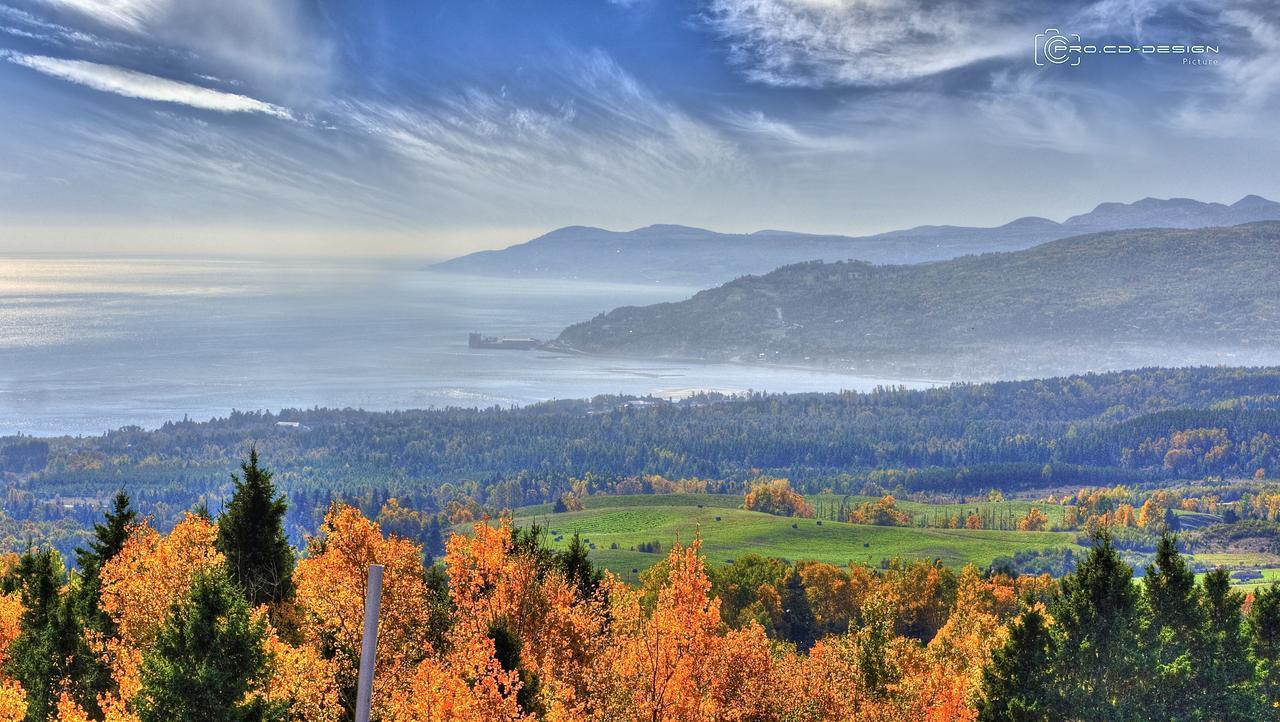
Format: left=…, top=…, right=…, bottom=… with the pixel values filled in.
left=0, top=454, right=1280, bottom=722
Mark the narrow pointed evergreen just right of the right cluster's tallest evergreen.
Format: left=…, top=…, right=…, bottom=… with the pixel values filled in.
left=1142, top=531, right=1204, bottom=719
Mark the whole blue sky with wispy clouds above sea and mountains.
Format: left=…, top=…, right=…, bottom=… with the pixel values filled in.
left=0, top=0, right=1280, bottom=256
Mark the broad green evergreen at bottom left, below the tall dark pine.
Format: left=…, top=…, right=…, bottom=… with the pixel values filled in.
left=134, top=575, right=274, bottom=722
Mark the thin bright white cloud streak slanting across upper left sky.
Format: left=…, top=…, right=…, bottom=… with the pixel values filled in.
left=0, top=52, right=291, bottom=118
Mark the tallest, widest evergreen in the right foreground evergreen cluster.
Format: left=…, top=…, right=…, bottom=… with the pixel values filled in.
left=1051, top=531, right=1151, bottom=721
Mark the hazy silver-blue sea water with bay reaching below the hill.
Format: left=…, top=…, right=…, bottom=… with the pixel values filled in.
left=0, top=257, right=921, bottom=435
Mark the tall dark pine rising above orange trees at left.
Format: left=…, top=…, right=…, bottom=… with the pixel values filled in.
left=218, top=448, right=293, bottom=607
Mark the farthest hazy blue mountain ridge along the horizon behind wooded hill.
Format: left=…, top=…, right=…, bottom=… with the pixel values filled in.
left=431, top=196, right=1280, bottom=287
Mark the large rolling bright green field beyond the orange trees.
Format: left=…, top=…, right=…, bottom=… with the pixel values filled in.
left=515, top=494, right=1075, bottom=579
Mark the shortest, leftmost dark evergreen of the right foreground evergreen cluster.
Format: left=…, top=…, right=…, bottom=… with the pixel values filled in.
left=978, top=607, right=1056, bottom=722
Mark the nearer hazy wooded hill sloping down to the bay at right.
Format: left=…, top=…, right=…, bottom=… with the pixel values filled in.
left=559, top=221, right=1280, bottom=378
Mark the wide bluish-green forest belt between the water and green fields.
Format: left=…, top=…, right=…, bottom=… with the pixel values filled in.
left=0, top=367, right=1280, bottom=552
